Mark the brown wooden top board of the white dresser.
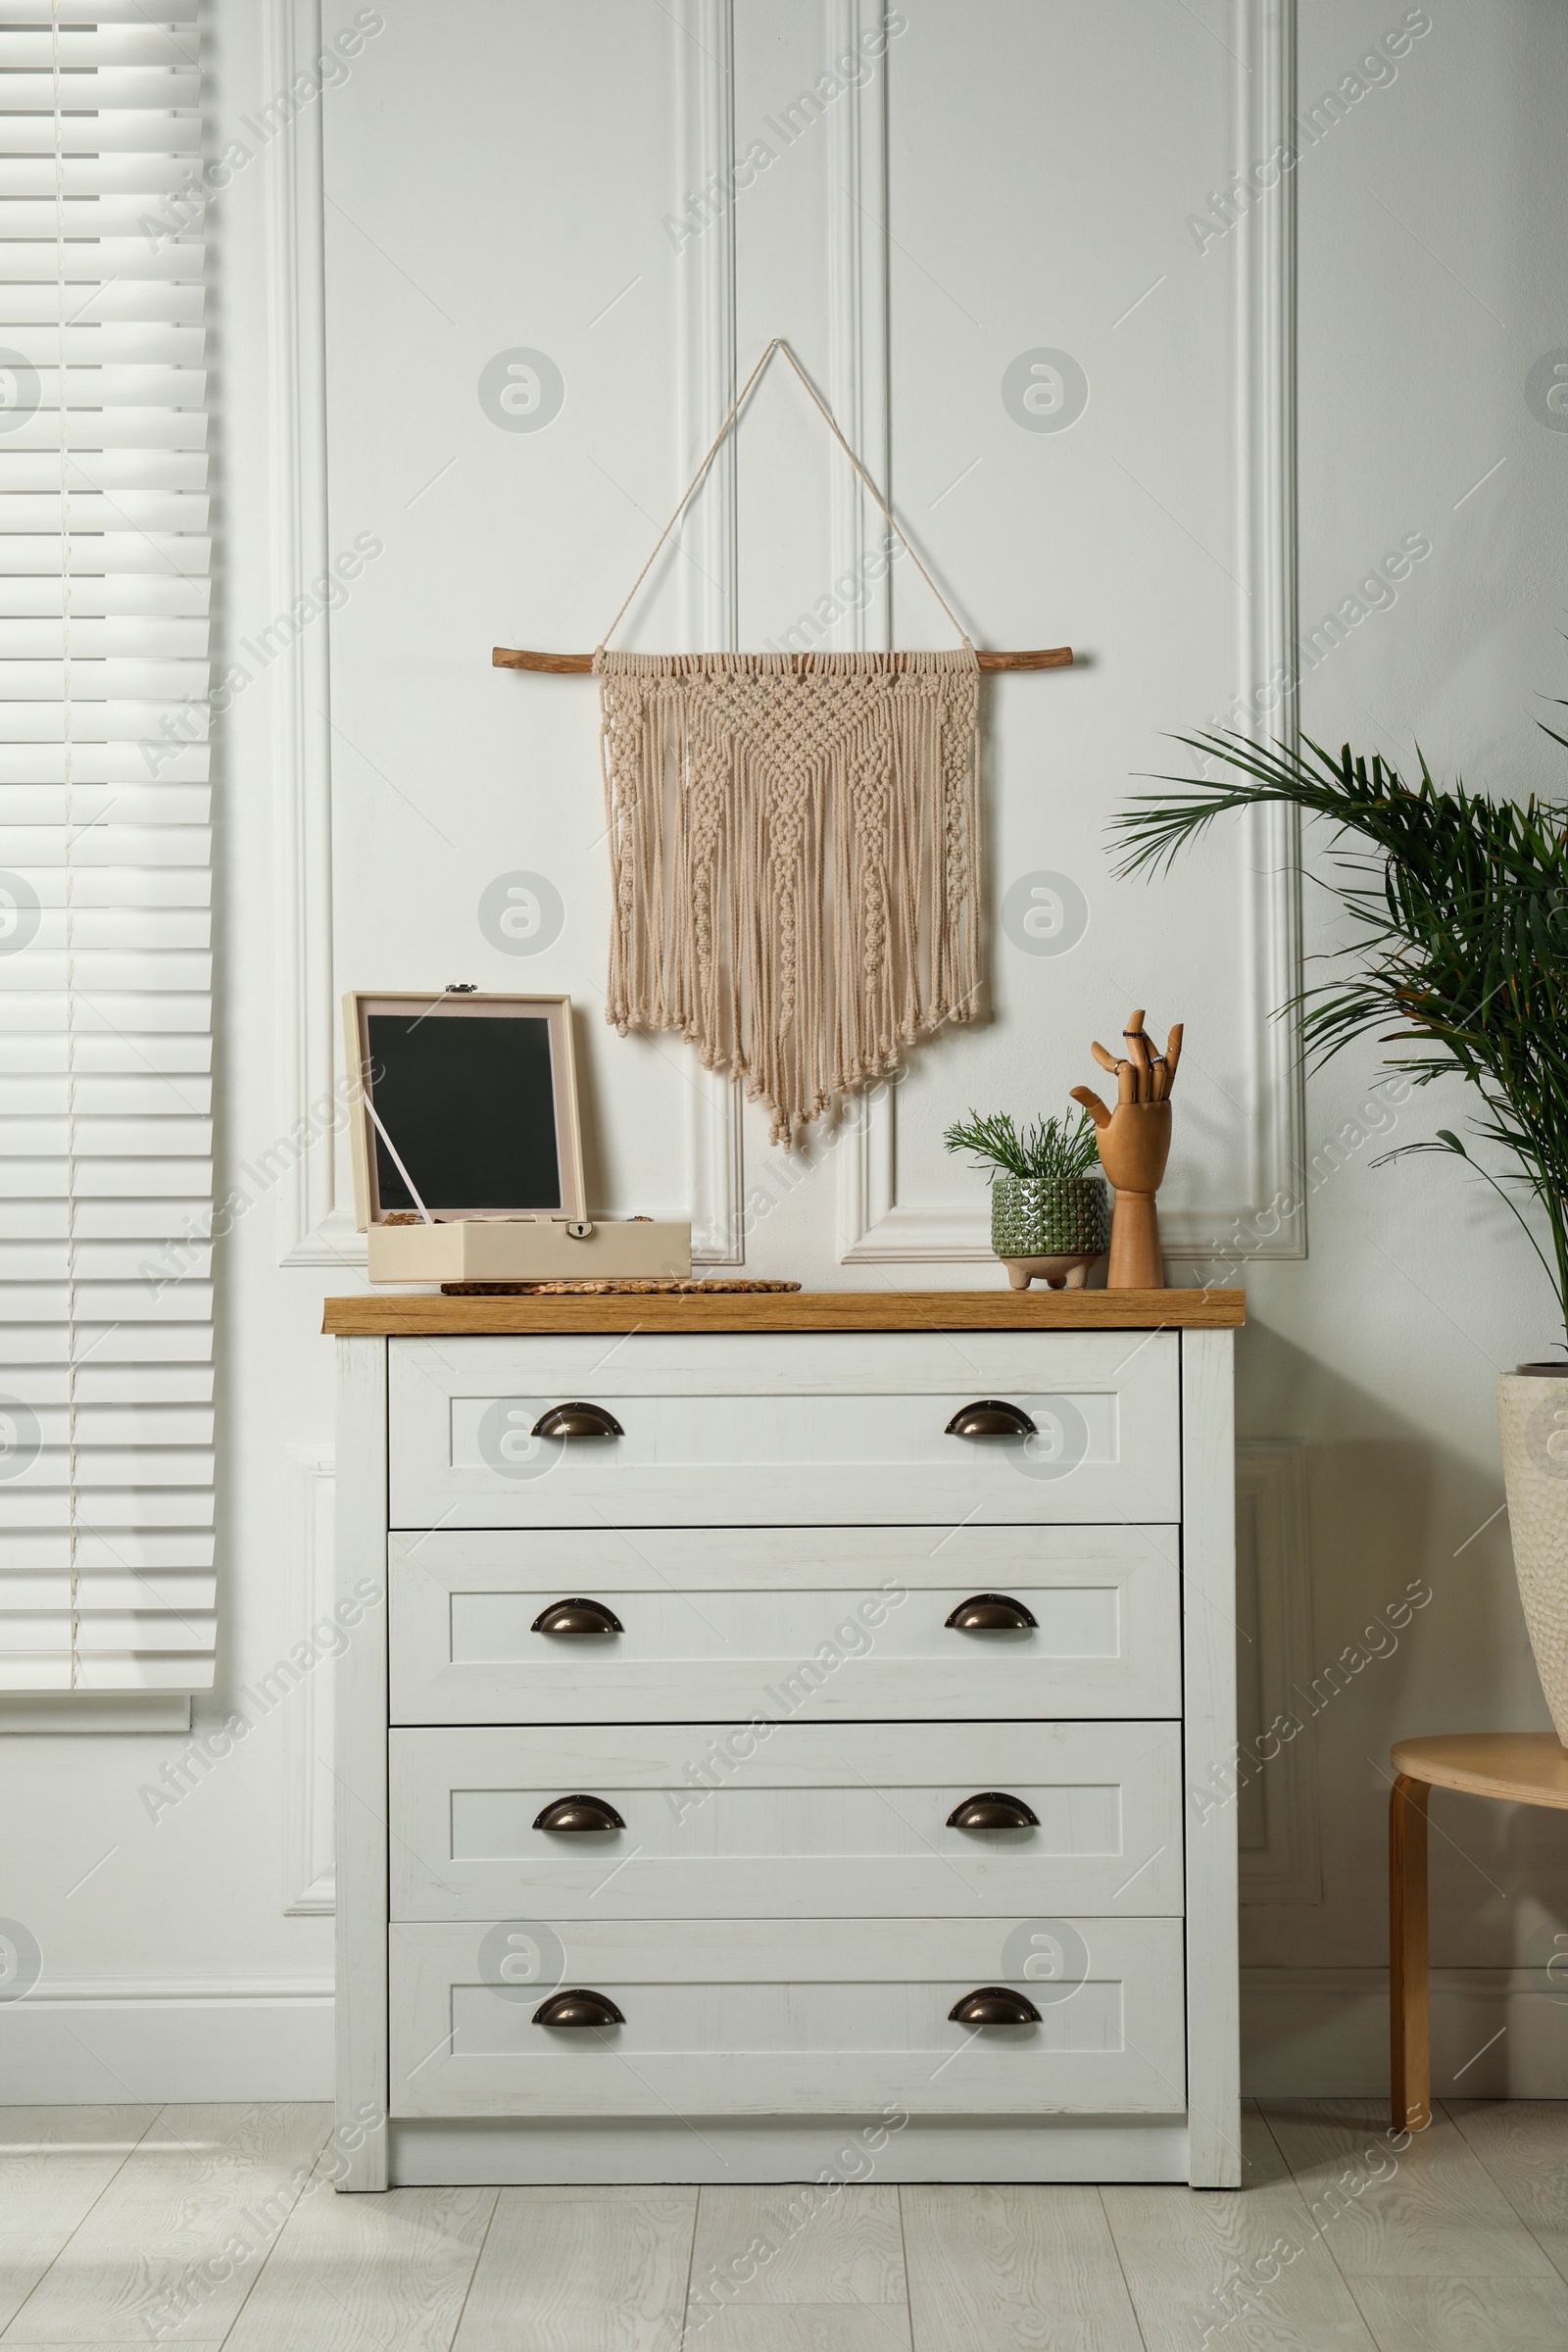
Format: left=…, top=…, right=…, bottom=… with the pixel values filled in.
left=322, top=1289, right=1246, bottom=1339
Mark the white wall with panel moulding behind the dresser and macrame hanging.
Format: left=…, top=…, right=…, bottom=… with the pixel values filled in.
left=0, top=0, right=1568, bottom=2098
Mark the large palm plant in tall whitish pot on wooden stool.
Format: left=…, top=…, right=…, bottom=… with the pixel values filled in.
left=1112, top=727, right=1568, bottom=1747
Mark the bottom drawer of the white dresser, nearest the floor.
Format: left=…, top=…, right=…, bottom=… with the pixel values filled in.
left=390, top=1917, right=1185, bottom=2122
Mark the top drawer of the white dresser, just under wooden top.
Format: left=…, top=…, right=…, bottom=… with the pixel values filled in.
left=388, top=1331, right=1180, bottom=1529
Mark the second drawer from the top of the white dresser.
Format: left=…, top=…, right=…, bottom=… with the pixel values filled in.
left=388, top=1527, right=1180, bottom=1724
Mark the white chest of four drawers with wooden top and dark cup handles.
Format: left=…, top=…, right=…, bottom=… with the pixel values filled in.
left=326, top=1292, right=1242, bottom=2189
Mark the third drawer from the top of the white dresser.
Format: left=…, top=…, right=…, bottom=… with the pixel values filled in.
left=390, top=1724, right=1183, bottom=1919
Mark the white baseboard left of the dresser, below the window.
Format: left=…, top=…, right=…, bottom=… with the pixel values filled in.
left=0, top=1978, right=331, bottom=2107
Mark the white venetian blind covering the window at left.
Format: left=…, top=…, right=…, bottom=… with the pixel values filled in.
left=0, top=0, right=214, bottom=1691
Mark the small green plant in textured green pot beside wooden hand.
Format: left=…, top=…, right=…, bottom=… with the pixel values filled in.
left=943, top=1110, right=1109, bottom=1289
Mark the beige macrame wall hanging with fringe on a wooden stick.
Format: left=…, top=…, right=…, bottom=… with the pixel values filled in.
left=491, top=339, right=1072, bottom=1148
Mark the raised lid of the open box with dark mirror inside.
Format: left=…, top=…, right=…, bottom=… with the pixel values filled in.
left=343, top=990, right=588, bottom=1233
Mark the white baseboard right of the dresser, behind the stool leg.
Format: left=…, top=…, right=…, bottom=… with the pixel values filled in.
left=1242, top=1969, right=1568, bottom=2098
